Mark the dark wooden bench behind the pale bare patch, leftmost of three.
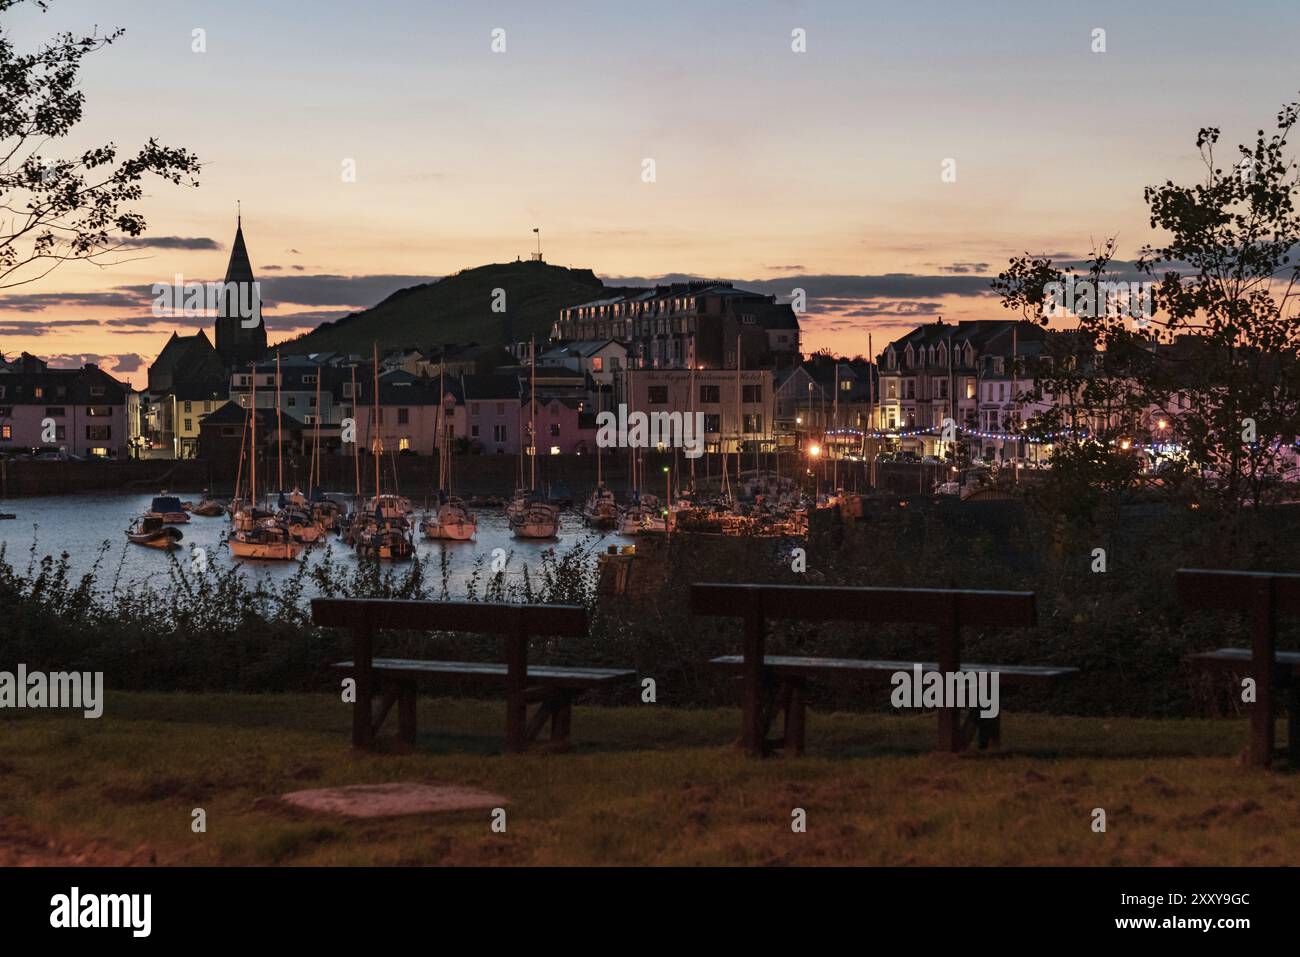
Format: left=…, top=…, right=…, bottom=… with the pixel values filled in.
left=312, top=598, right=636, bottom=753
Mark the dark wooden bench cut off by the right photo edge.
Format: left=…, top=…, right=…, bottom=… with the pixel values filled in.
left=1177, top=568, right=1300, bottom=767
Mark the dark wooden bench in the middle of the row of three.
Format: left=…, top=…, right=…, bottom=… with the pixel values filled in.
left=690, top=583, right=1078, bottom=755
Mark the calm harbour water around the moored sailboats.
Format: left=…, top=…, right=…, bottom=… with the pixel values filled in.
left=0, top=493, right=636, bottom=594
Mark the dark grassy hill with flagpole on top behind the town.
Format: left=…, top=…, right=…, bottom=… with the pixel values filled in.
left=280, top=263, right=634, bottom=354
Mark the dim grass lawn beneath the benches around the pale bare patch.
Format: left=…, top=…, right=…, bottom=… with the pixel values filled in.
left=0, top=693, right=1300, bottom=865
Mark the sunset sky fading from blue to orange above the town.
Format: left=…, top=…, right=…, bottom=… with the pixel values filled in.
left=0, top=0, right=1300, bottom=386
